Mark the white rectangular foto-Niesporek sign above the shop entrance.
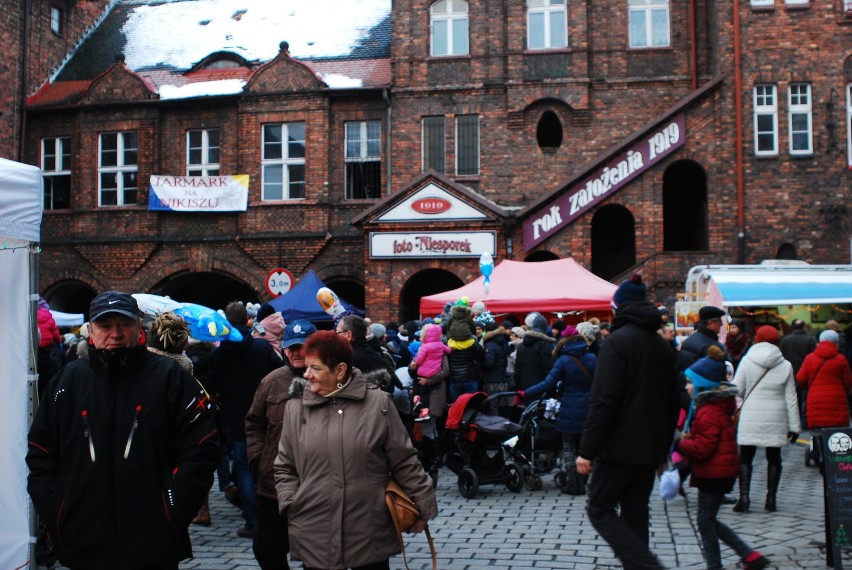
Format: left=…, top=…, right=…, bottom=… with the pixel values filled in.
left=370, top=232, right=497, bottom=259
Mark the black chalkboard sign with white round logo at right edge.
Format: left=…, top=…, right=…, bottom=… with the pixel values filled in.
left=821, top=428, right=852, bottom=570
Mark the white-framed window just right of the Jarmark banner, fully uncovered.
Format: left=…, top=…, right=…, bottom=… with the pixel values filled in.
left=262, top=123, right=305, bottom=200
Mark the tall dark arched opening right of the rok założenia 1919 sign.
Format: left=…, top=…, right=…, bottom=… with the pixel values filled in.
left=663, top=160, right=708, bottom=251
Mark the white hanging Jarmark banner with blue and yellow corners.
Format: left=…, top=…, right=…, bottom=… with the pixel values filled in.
left=148, top=174, right=249, bottom=212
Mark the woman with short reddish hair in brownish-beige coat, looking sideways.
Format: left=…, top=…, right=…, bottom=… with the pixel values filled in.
left=274, top=331, right=438, bottom=570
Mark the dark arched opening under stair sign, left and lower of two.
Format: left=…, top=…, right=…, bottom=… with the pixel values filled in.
left=592, top=204, right=636, bottom=281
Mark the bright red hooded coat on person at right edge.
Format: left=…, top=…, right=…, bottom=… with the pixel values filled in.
left=796, top=340, right=852, bottom=429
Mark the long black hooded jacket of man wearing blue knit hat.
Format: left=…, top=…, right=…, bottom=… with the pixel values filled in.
left=580, top=299, right=680, bottom=465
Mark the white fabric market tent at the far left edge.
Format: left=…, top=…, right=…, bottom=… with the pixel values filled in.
left=0, top=158, right=42, bottom=568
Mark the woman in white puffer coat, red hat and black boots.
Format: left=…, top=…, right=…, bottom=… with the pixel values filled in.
left=734, top=325, right=802, bottom=513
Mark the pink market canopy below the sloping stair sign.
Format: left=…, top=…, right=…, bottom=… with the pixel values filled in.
left=420, top=258, right=617, bottom=316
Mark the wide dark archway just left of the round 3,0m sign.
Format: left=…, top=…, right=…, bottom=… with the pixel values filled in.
left=151, top=272, right=260, bottom=309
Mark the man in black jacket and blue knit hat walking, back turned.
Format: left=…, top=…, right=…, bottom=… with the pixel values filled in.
left=577, top=275, right=679, bottom=570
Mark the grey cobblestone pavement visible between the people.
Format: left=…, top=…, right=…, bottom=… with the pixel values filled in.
left=180, top=430, right=852, bottom=570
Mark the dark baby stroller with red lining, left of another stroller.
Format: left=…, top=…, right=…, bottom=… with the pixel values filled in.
left=440, top=392, right=531, bottom=499
